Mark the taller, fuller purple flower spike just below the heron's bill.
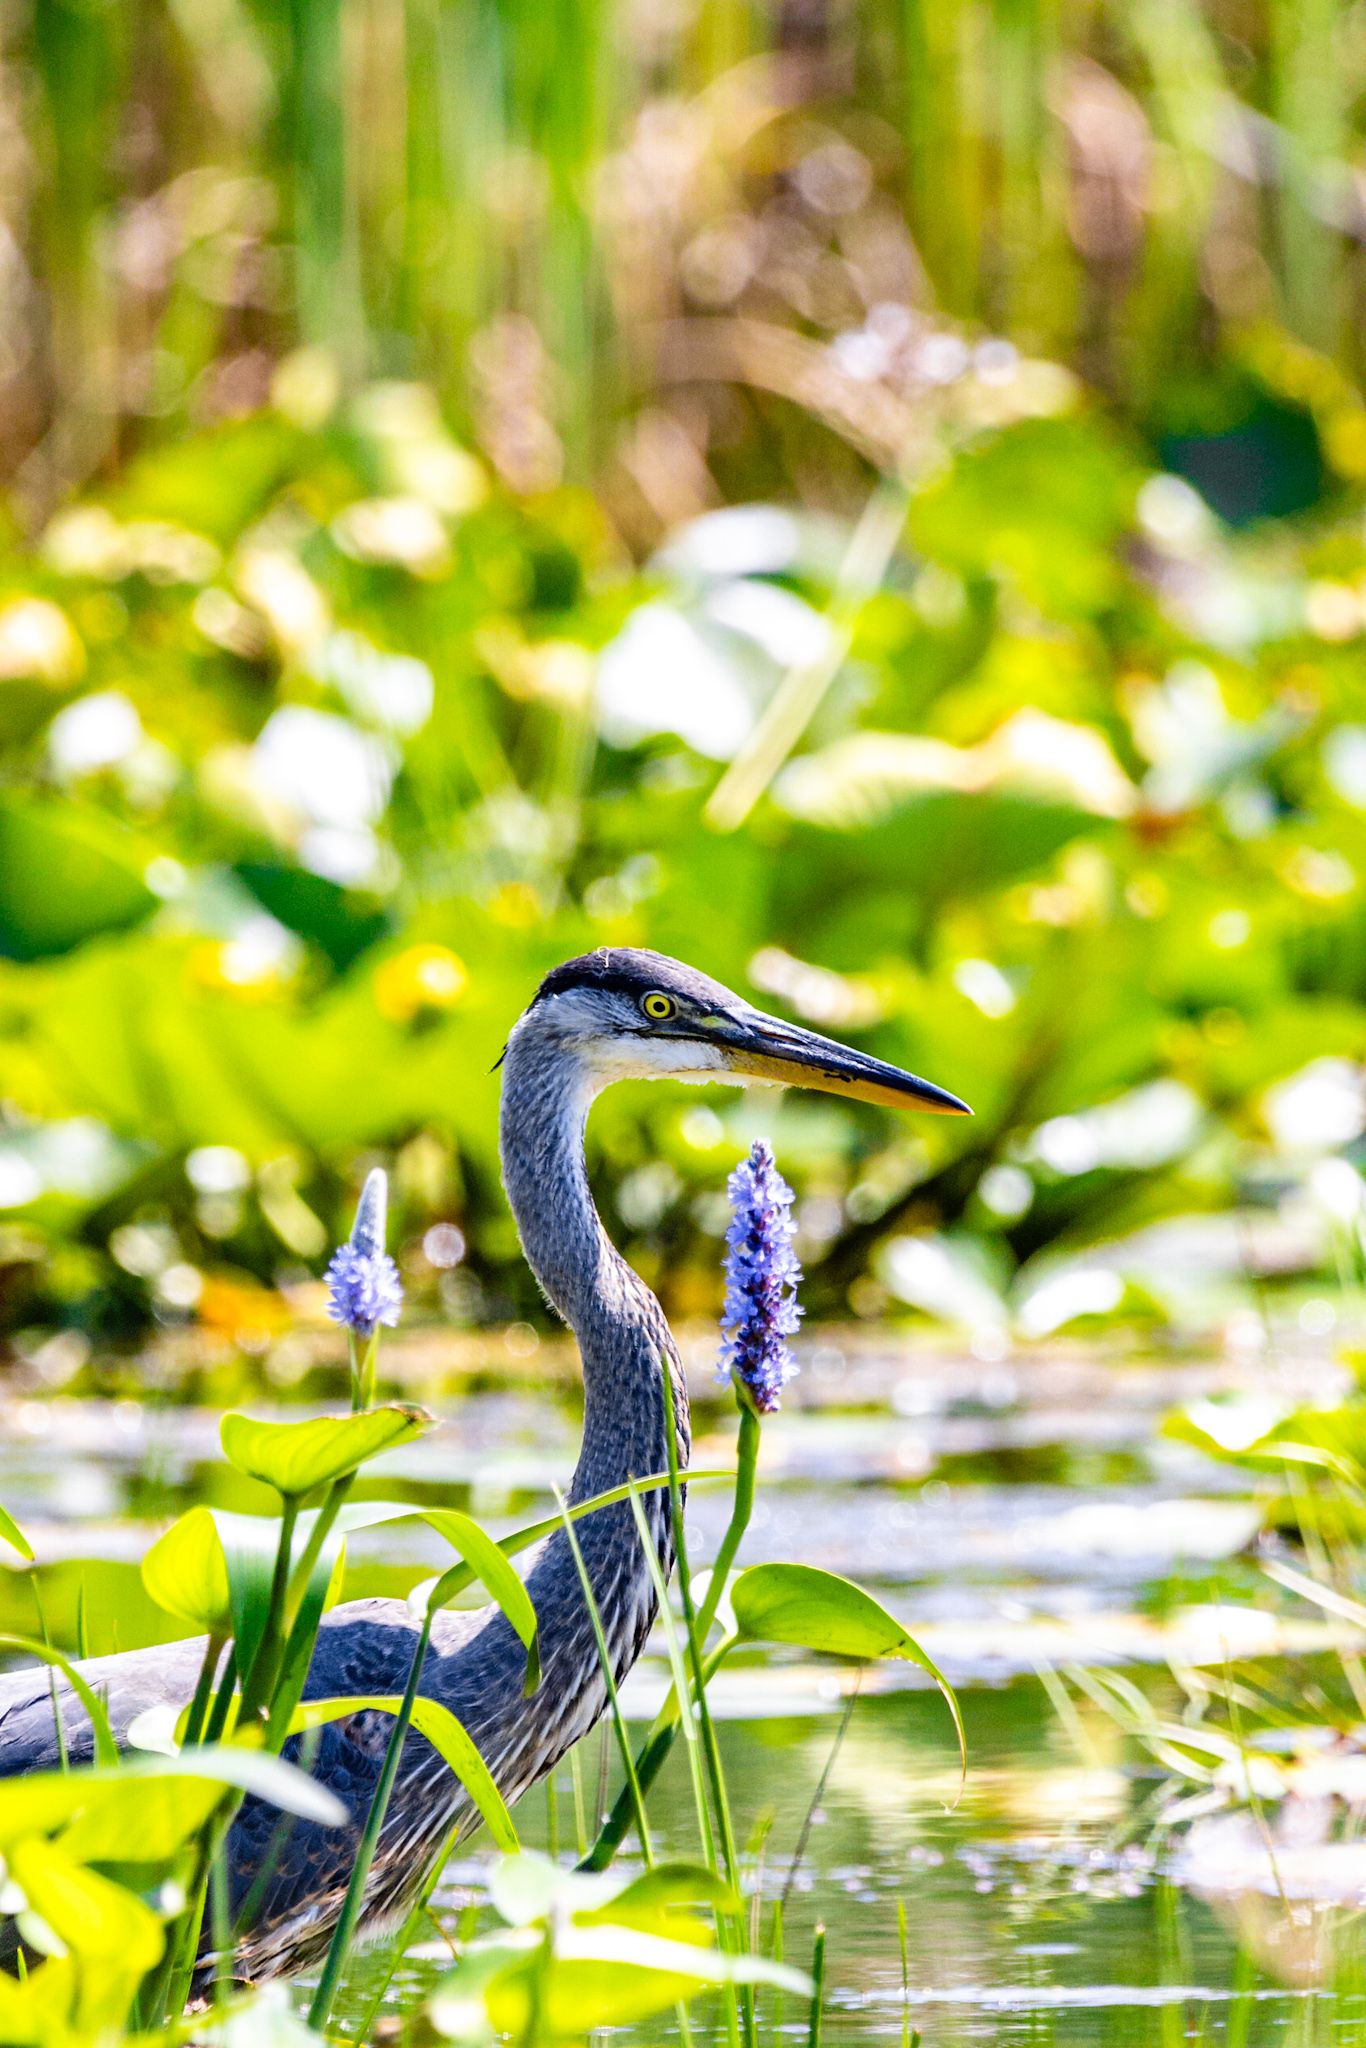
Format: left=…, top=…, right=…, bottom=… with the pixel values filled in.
left=717, top=1139, right=801, bottom=1415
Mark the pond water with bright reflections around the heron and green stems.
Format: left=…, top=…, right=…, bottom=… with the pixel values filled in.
left=0, top=1333, right=1366, bottom=2048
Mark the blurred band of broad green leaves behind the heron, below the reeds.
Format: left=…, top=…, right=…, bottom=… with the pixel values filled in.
left=0, top=354, right=1366, bottom=1362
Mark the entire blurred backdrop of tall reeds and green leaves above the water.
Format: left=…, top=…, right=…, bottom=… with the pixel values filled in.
left=0, top=0, right=1366, bottom=1378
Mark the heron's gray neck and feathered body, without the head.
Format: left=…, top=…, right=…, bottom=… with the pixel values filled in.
left=0, top=966, right=688, bottom=1978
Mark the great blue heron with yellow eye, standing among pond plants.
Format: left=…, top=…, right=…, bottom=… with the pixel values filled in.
left=0, top=946, right=967, bottom=1978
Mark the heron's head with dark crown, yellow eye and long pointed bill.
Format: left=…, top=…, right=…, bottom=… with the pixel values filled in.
left=512, top=946, right=971, bottom=1116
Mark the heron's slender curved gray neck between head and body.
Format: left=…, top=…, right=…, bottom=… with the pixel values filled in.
left=500, top=1034, right=688, bottom=1499
